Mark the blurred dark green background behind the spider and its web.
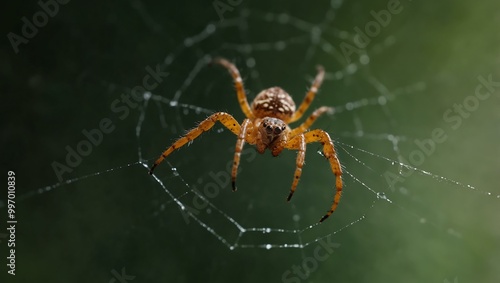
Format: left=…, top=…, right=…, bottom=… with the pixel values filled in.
left=0, top=0, right=500, bottom=283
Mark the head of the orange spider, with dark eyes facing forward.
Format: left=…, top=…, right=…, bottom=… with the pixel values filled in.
left=259, top=117, right=288, bottom=155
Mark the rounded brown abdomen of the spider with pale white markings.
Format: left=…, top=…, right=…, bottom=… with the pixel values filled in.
left=252, top=87, right=295, bottom=122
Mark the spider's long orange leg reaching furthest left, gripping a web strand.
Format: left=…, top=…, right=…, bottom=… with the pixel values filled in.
left=149, top=112, right=241, bottom=174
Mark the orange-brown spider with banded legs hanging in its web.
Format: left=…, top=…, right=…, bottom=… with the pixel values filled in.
left=149, top=58, right=342, bottom=223
